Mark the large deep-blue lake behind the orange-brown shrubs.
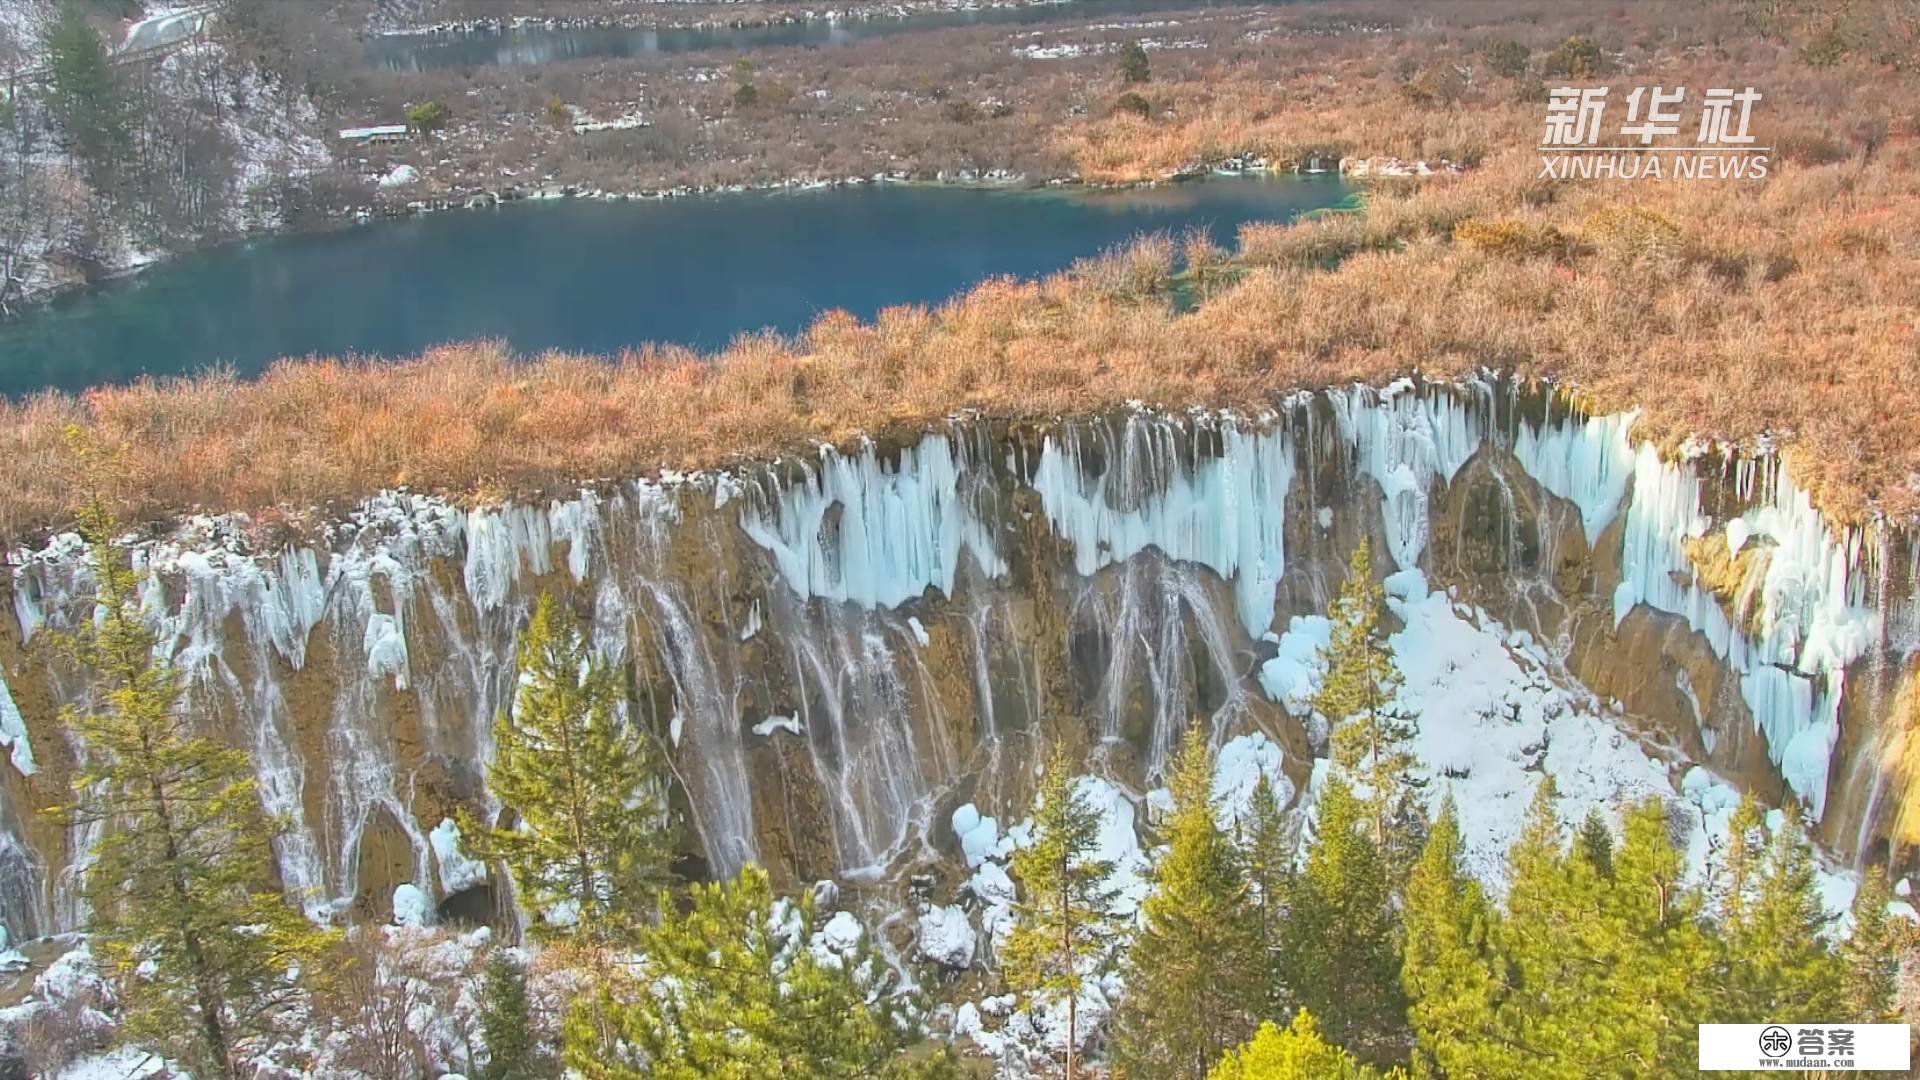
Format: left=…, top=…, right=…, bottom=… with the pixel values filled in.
left=0, top=179, right=1352, bottom=396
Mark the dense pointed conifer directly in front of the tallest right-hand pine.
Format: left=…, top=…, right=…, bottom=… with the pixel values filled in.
left=1283, top=774, right=1407, bottom=1061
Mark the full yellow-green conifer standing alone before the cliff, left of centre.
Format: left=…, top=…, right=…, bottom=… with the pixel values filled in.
left=467, top=596, right=672, bottom=949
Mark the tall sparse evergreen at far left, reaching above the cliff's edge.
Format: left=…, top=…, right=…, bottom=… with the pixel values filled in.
left=56, top=447, right=334, bottom=1078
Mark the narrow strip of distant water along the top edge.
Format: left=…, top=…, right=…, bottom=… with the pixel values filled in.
left=367, top=0, right=1260, bottom=71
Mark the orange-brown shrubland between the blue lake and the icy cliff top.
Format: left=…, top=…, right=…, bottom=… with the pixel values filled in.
left=0, top=6, right=1920, bottom=534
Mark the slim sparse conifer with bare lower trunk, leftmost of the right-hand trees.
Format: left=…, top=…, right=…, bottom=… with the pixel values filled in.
left=1000, top=748, right=1116, bottom=1080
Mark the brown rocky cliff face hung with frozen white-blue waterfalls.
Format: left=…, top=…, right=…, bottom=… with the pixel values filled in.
left=0, top=380, right=1920, bottom=936
